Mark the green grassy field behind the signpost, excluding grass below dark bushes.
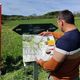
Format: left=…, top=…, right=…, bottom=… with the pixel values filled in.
left=2, top=19, right=80, bottom=58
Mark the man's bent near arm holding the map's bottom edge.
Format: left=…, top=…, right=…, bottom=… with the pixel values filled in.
left=37, top=50, right=66, bottom=71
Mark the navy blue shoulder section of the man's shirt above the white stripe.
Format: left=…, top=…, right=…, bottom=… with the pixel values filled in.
left=56, top=30, right=80, bottom=52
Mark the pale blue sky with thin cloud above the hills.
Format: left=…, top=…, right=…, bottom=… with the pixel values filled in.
left=0, top=0, right=80, bottom=16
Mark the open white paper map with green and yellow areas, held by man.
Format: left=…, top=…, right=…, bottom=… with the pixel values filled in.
left=23, top=34, right=55, bottom=62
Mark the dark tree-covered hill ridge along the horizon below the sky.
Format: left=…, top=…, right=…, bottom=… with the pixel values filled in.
left=2, top=11, right=80, bottom=20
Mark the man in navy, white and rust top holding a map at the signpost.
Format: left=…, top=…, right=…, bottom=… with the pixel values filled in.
left=37, top=10, right=80, bottom=80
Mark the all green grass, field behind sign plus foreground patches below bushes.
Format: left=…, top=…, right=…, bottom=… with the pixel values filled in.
left=0, top=19, right=80, bottom=80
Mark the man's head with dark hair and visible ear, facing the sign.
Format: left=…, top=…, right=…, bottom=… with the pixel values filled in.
left=58, top=10, right=74, bottom=32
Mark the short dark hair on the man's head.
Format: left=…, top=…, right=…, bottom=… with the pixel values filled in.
left=58, top=10, right=74, bottom=24
